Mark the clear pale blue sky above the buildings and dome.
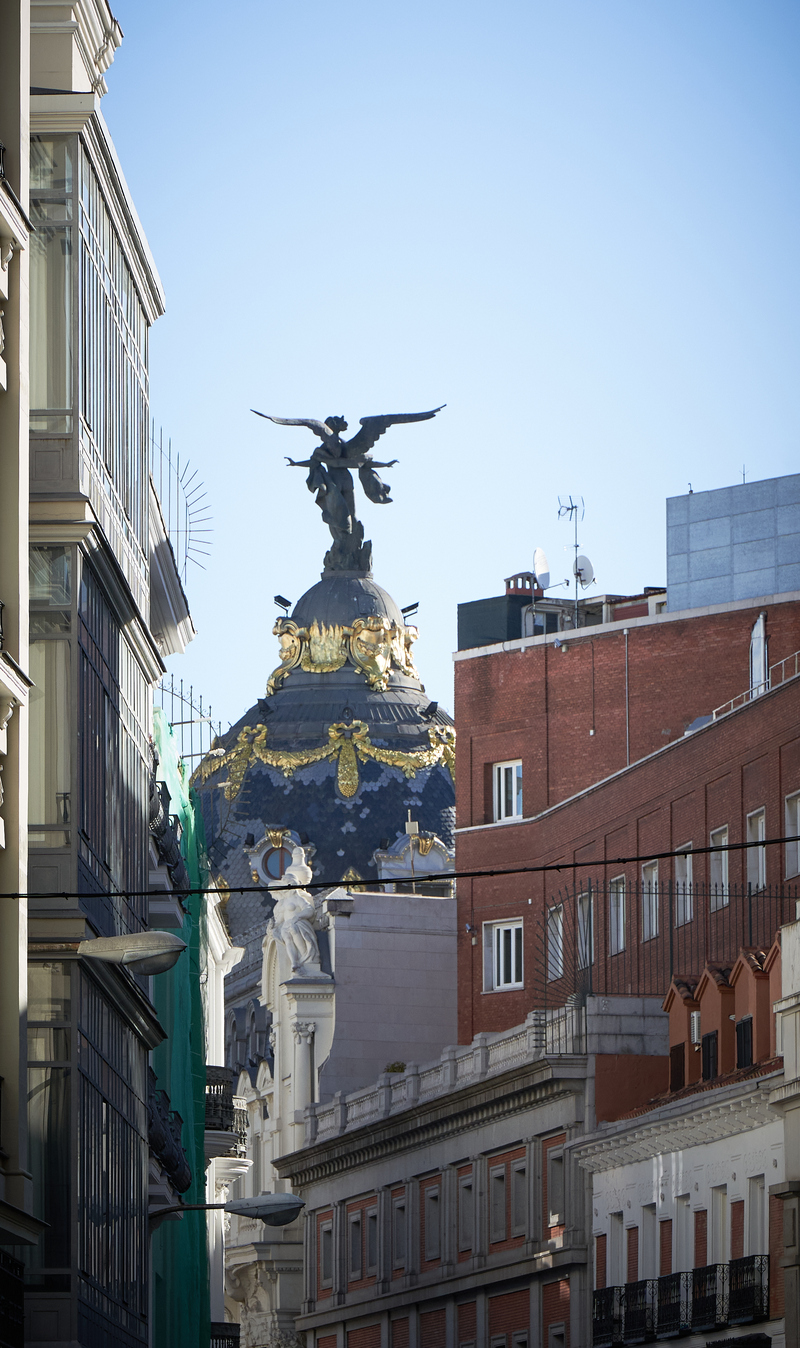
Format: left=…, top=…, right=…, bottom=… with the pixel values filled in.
left=103, top=0, right=800, bottom=725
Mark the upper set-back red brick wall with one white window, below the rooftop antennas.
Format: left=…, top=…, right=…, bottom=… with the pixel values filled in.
left=455, top=603, right=800, bottom=828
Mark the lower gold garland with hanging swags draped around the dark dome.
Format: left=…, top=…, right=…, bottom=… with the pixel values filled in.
left=192, top=721, right=456, bottom=801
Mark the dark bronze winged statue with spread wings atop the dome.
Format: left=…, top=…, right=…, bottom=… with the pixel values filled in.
left=251, top=403, right=445, bottom=572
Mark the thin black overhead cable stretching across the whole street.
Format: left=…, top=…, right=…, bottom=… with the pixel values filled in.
left=0, top=834, right=800, bottom=899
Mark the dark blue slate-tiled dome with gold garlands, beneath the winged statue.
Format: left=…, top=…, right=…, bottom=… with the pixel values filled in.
left=193, top=572, right=455, bottom=911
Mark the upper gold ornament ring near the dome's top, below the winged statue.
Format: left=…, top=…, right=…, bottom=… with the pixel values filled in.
left=267, top=613, right=420, bottom=697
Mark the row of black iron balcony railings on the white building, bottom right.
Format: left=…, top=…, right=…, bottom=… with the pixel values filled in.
left=592, top=1255, right=769, bottom=1348
